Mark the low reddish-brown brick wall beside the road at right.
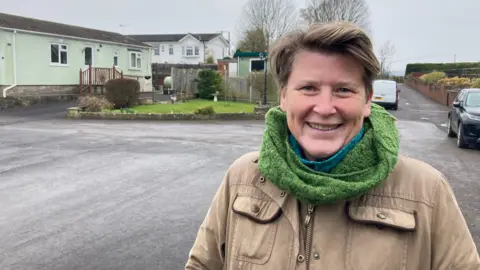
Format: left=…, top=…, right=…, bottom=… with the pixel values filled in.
left=405, top=79, right=459, bottom=106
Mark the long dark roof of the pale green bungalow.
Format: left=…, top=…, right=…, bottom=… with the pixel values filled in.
left=0, top=13, right=149, bottom=47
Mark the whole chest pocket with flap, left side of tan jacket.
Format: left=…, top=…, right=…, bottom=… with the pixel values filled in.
left=231, top=195, right=281, bottom=264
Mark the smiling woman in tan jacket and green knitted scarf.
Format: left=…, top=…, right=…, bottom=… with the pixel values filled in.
left=186, top=23, right=480, bottom=270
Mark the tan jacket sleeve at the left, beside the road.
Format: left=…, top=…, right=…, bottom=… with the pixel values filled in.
left=185, top=172, right=230, bottom=270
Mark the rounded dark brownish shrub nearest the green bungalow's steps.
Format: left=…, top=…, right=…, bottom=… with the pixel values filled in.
left=105, top=79, right=140, bottom=109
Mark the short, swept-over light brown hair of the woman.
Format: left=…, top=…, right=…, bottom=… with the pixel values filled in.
left=269, top=22, right=380, bottom=98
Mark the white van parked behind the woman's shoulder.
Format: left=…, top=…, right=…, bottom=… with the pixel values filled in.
left=372, top=80, right=400, bottom=110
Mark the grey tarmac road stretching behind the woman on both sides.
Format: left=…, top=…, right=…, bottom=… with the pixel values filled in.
left=0, top=86, right=480, bottom=270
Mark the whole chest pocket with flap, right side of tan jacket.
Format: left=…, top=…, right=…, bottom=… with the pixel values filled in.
left=346, top=206, right=416, bottom=270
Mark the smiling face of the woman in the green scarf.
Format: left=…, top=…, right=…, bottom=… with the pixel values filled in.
left=280, top=51, right=371, bottom=160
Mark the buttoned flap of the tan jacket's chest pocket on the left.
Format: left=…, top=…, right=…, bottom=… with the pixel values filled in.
left=232, top=196, right=282, bottom=223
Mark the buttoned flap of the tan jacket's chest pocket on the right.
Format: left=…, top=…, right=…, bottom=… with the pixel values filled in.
left=348, top=206, right=416, bottom=231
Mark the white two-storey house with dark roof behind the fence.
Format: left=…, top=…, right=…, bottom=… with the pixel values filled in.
left=129, top=33, right=230, bottom=64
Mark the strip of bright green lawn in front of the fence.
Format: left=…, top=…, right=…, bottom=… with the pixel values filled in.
left=116, top=99, right=255, bottom=113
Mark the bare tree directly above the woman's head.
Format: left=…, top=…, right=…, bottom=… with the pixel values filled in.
left=300, top=0, right=370, bottom=32
